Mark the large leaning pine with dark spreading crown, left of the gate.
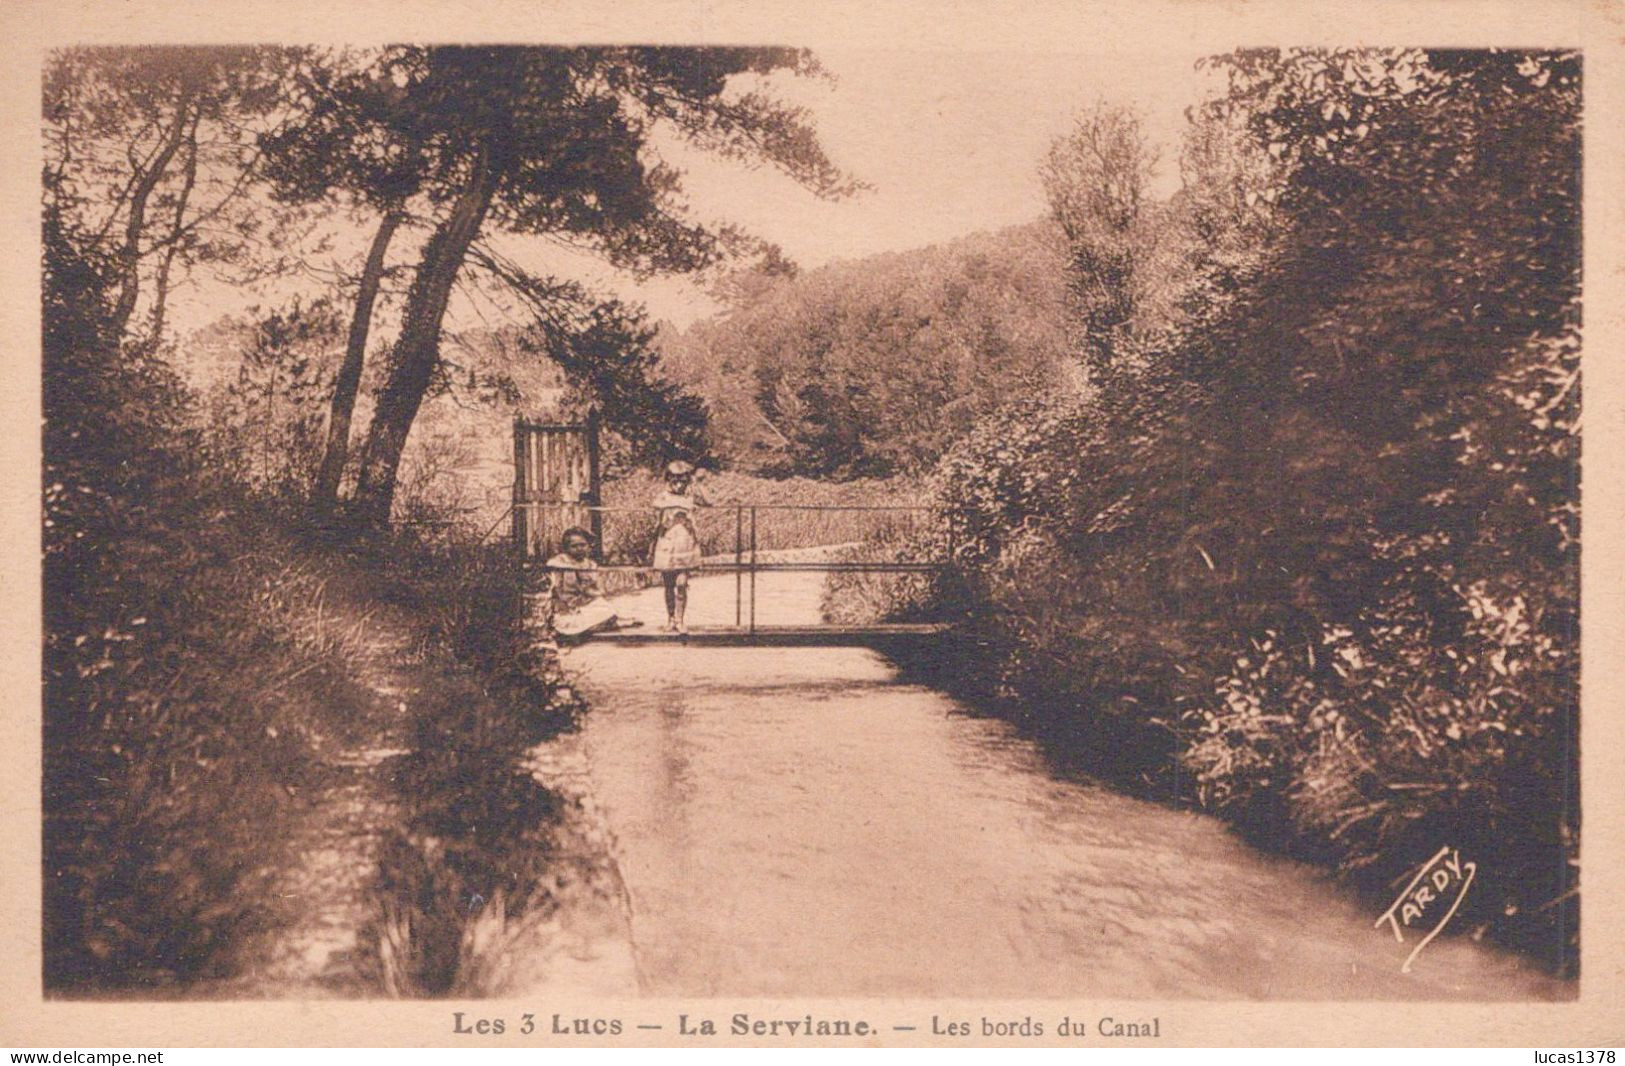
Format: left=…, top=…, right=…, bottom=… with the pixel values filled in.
left=263, top=47, right=855, bottom=525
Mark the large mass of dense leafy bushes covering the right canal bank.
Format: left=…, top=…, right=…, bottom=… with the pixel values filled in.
left=864, top=50, right=1580, bottom=967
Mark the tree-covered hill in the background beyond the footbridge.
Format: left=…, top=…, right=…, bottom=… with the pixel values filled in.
left=661, top=224, right=1068, bottom=478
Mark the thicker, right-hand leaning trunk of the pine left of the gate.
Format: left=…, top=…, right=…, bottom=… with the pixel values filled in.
left=354, top=148, right=497, bottom=528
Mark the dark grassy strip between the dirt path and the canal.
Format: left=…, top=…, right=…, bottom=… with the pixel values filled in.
left=359, top=529, right=619, bottom=996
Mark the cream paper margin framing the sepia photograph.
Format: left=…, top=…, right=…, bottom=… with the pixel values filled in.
left=0, top=0, right=1625, bottom=1050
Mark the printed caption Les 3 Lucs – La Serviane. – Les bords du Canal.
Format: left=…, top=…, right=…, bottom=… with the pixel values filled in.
left=452, top=1011, right=1162, bottom=1040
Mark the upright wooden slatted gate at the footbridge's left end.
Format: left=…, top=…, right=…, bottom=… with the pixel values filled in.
left=514, top=411, right=603, bottom=561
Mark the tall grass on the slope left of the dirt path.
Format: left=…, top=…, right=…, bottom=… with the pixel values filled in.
left=42, top=499, right=369, bottom=993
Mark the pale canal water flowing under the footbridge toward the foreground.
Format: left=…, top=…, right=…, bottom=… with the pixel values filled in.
left=552, top=574, right=1573, bottom=999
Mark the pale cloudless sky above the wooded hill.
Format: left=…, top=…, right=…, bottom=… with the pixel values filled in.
left=510, top=49, right=1206, bottom=325
